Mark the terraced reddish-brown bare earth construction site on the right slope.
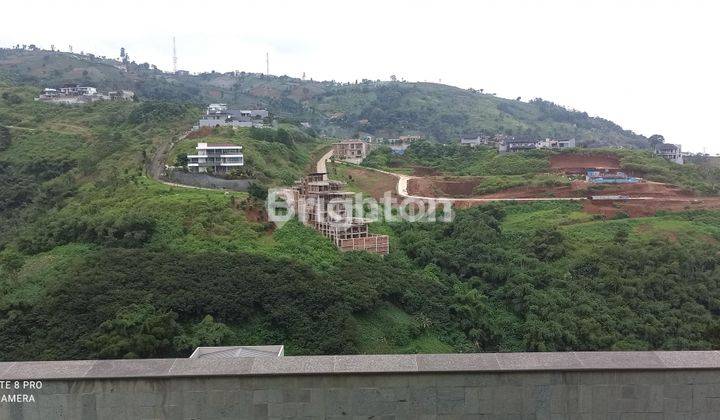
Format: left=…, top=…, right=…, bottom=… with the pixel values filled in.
left=328, top=153, right=720, bottom=217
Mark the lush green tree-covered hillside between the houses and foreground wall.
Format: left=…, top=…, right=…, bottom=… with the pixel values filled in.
left=0, top=62, right=720, bottom=360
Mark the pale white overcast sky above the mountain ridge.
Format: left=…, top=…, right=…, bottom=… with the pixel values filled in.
left=0, top=0, right=720, bottom=153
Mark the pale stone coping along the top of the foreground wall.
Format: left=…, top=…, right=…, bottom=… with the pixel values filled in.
left=0, top=351, right=720, bottom=380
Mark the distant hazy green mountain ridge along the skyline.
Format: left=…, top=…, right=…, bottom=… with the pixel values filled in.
left=0, top=49, right=647, bottom=147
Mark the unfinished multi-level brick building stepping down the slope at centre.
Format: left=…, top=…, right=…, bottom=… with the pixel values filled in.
left=293, top=173, right=389, bottom=255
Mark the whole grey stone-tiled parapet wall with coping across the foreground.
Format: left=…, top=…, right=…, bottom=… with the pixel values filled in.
left=0, top=352, right=720, bottom=419
